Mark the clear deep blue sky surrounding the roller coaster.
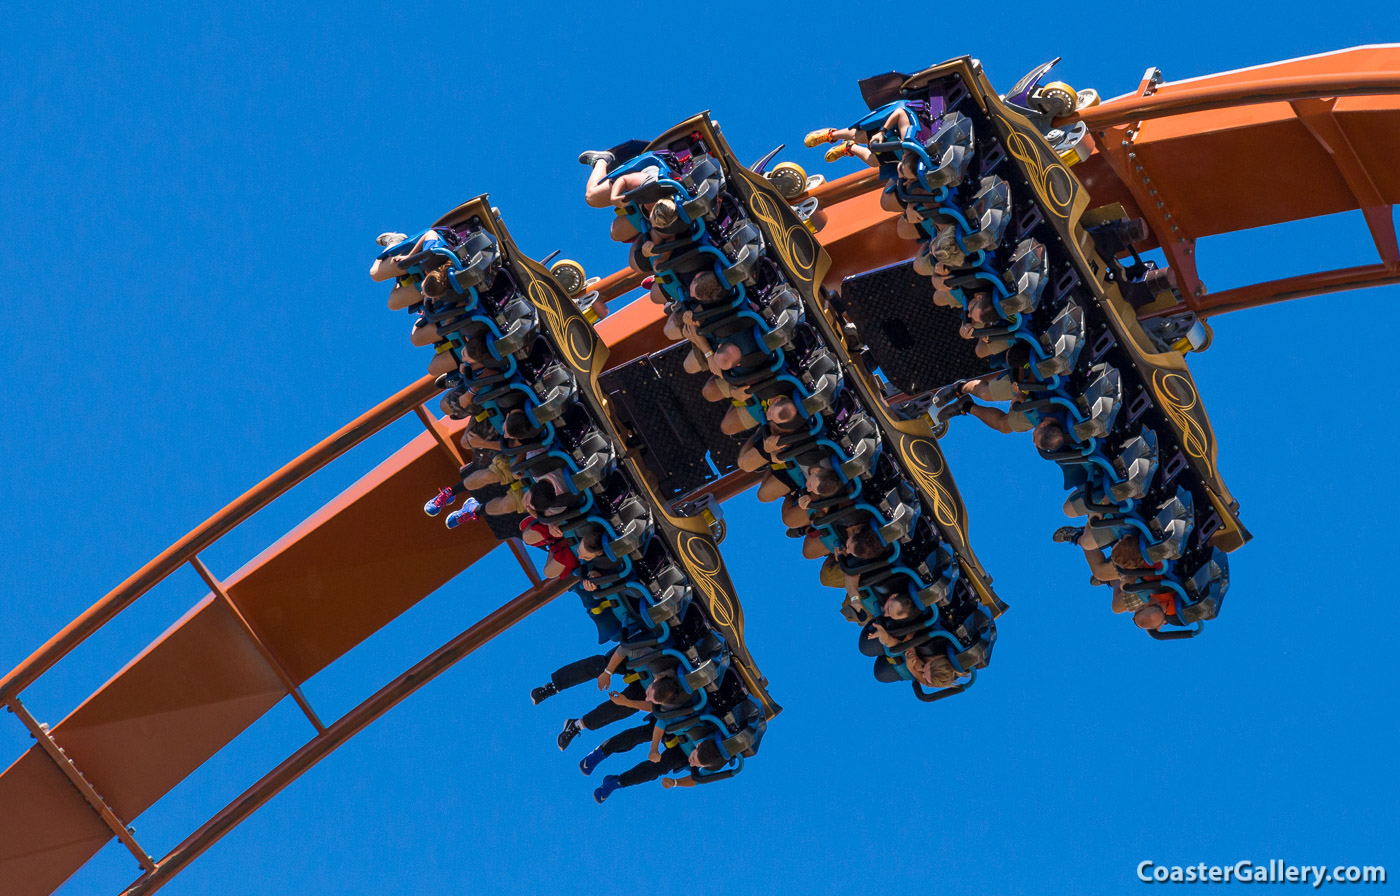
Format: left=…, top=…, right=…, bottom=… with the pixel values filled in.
left=0, top=1, right=1400, bottom=895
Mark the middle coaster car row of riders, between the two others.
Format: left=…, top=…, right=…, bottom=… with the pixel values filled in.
left=581, top=115, right=1002, bottom=701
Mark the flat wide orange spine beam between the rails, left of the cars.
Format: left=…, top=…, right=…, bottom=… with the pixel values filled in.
left=0, top=406, right=497, bottom=896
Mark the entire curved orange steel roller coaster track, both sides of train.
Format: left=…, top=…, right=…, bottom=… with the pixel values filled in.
left=0, top=46, right=1400, bottom=896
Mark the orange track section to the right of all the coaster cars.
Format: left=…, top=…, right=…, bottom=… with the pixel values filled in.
left=1074, top=45, right=1400, bottom=316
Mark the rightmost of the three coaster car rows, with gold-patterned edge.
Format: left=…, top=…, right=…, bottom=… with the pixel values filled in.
left=834, top=57, right=1249, bottom=640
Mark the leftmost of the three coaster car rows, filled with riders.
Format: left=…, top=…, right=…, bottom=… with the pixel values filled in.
left=371, top=197, right=778, bottom=783
